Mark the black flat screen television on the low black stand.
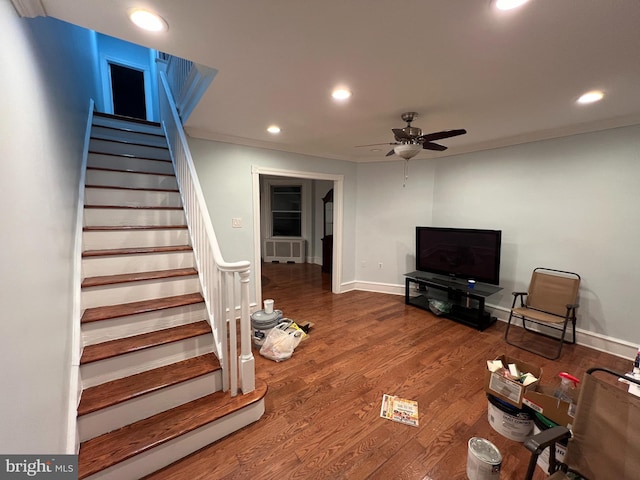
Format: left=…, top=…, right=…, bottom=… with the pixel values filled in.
left=416, top=227, right=502, bottom=285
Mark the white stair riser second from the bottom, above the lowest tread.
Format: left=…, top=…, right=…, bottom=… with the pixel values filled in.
left=78, top=370, right=222, bottom=442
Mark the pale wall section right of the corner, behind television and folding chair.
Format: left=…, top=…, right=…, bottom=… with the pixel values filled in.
left=433, top=125, right=640, bottom=346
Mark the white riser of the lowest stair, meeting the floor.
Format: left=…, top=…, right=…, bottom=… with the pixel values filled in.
left=87, top=399, right=264, bottom=480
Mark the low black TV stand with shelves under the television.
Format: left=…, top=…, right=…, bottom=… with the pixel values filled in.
left=405, top=271, right=502, bottom=331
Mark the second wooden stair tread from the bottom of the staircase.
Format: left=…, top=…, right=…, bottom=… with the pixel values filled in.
left=78, top=352, right=220, bottom=416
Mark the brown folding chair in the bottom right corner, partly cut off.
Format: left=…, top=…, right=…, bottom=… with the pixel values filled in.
left=524, top=368, right=640, bottom=480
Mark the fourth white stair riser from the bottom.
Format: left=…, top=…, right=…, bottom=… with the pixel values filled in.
left=82, top=302, right=207, bottom=346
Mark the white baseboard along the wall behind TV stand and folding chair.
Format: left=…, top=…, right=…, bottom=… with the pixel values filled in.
left=350, top=281, right=638, bottom=362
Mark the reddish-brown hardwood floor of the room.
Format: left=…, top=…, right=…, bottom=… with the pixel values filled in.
left=151, top=264, right=630, bottom=480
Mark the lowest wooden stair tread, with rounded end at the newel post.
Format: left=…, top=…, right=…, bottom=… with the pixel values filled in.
left=78, top=380, right=267, bottom=479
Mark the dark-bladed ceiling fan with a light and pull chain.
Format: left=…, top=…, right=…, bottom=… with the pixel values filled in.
left=358, top=112, right=467, bottom=160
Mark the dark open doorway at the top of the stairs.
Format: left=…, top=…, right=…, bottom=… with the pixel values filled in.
left=109, top=63, right=147, bottom=120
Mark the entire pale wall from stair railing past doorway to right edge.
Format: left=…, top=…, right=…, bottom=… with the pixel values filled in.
left=190, top=126, right=640, bottom=348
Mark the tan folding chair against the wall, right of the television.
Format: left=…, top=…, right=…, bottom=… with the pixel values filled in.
left=504, top=267, right=580, bottom=360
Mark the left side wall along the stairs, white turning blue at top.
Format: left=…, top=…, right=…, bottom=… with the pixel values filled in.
left=0, top=9, right=96, bottom=454
